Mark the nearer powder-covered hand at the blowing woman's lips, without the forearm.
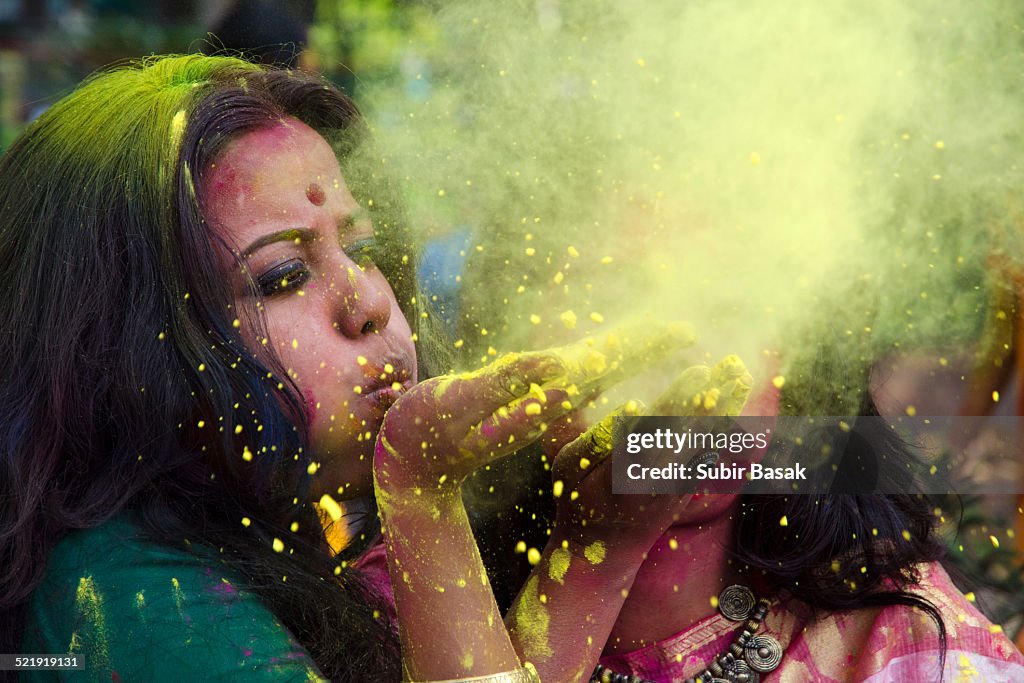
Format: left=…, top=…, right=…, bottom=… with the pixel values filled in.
left=375, top=325, right=693, bottom=490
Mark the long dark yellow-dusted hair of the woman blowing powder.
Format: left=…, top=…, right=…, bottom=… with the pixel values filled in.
left=0, top=55, right=446, bottom=681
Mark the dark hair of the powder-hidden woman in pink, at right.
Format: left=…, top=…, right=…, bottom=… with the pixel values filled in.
left=733, top=342, right=946, bottom=674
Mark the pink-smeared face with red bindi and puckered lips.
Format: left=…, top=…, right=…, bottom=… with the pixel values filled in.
left=203, top=118, right=416, bottom=498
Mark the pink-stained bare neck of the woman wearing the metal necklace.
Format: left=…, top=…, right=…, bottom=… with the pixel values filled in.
left=604, top=497, right=742, bottom=654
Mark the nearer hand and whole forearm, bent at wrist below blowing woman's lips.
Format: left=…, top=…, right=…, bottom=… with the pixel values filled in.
left=374, top=326, right=693, bottom=680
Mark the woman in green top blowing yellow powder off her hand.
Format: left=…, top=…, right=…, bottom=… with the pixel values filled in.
left=0, top=56, right=704, bottom=681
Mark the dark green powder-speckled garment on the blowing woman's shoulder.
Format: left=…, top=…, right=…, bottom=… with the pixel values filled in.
left=22, top=518, right=324, bottom=683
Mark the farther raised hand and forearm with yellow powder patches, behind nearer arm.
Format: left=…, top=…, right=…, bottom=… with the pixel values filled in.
left=506, top=356, right=753, bottom=682
